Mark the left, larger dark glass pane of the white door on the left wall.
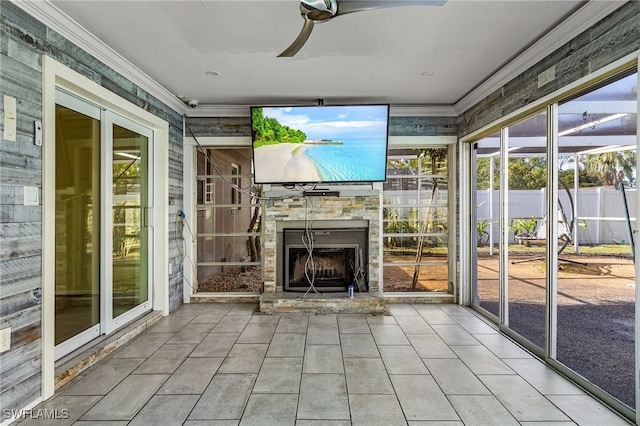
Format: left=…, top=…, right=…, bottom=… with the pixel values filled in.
left=55, top=105, right=100, bottom=345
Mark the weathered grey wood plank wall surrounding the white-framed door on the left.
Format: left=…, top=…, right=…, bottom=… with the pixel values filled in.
left=0, top=1, right=183, bottom=412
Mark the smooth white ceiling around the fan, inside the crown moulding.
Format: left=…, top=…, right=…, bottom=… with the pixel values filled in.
left=37, top=0, right=608, bottom=114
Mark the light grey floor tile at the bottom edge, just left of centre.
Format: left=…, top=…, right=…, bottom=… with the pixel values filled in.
left=240, top=394, right=298, bottom=426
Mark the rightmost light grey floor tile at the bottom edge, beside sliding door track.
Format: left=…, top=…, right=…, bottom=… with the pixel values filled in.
left=548, top=395, right=629, bottom=426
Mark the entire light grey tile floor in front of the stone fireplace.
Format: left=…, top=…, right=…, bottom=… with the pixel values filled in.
left=13, top=304, right=628, bottom=426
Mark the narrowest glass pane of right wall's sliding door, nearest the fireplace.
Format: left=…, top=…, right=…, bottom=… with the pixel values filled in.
left=471, top=133, right=500, bottom=316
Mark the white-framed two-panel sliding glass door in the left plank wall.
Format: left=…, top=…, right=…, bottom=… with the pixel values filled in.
left=55, top=91, right=152, bottom=358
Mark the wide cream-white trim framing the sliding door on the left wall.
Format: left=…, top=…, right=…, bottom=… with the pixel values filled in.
left=42, top=55, right=169, bottom=399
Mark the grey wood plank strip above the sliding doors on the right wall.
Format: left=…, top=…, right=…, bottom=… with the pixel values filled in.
left=458, top=1, right=640, bottom=137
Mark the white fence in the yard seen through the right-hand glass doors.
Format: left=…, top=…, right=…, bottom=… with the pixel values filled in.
left=477, top=187, right=636, bottom=244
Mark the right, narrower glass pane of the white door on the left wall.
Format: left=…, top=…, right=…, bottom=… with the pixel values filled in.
left=112, top=125, right=149, bottom=318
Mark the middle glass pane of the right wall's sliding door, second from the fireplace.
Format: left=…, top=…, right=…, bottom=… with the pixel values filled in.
left=503, top=112, right=547, bottom=348
